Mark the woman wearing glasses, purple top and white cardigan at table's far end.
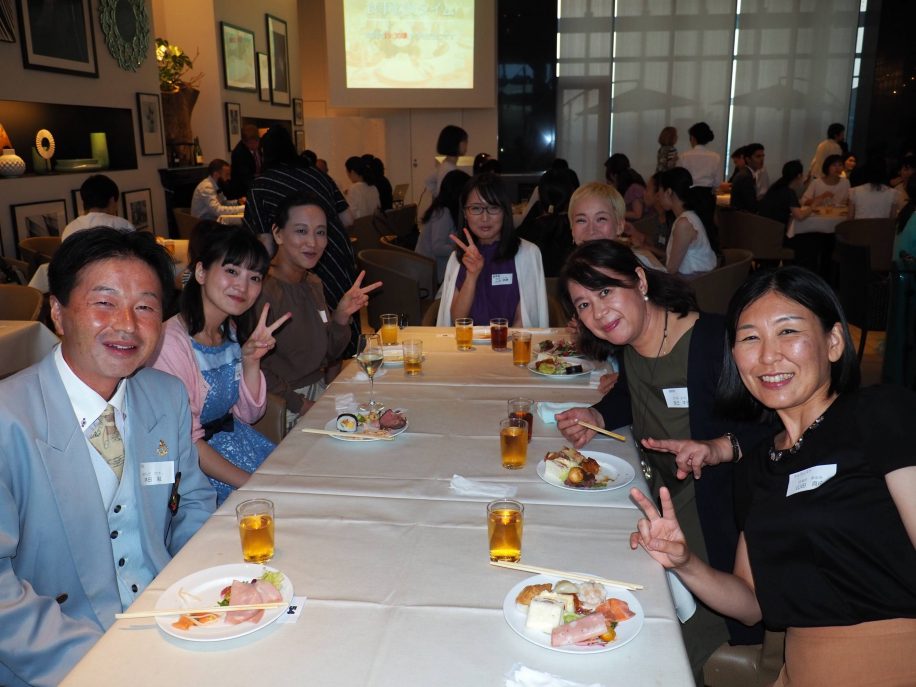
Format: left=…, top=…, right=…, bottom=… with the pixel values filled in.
left=436, top=173, right=549, bottom=327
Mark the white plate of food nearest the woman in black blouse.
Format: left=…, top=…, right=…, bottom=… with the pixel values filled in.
left=503, top=575, right=645, bottom=654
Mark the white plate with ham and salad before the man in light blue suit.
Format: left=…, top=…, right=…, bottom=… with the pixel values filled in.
left=156, top=563, right=293, bottom=642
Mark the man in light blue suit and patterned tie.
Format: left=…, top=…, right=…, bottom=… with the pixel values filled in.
left=0, top=229, right=216, bottom=687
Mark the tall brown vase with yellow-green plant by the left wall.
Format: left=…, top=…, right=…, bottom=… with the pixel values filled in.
left=156, top=38, right=203, bottom=167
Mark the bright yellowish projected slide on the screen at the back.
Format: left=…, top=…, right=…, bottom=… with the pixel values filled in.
left=344, top=0, right=474, bottom=89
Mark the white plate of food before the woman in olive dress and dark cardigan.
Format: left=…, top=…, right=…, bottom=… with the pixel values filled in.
left=537, top=447, right=636, bottom=492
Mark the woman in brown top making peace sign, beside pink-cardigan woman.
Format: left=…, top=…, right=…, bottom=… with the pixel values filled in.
left=259, top=195, right=381, bottom=426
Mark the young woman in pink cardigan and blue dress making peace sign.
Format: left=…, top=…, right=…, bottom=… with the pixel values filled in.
left=153, top=227, right=290, bottom=503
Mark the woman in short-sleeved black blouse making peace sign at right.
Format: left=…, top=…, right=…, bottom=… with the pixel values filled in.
left=630, top=267, right=916, bottom=687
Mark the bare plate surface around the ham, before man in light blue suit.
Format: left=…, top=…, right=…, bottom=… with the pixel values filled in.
left=156, top=563, right=293, bottom=642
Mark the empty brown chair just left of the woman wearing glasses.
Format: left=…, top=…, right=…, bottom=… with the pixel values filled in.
left=357, top=248, right=436, bottom=326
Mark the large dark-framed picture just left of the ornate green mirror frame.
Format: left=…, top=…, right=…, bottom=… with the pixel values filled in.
left=19, top=0, right=99, bottom=78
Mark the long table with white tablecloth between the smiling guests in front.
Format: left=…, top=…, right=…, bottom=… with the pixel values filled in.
left=63, top=327, right=693, bottom=687
